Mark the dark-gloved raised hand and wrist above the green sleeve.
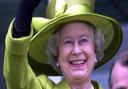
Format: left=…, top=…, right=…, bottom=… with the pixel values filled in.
left=13, top=0, right=41, bottom=38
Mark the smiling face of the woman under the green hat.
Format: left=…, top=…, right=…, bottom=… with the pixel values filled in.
left=58, top=22, right=95, bottom=82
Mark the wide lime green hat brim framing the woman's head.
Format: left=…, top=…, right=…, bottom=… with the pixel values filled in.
left=28, top=13, right=122, bottom=75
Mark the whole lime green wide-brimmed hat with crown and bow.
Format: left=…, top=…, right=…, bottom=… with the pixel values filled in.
left=28, top=0, right=122, bottom=75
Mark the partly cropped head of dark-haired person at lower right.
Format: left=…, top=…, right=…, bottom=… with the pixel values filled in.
left=109, top=51, right=128, bottom=89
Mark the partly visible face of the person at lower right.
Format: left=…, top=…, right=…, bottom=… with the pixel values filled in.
left=112, top=63, right=128, bottom=89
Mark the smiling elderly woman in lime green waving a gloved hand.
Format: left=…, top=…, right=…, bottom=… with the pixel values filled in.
left=4, top=0, right=122, bottom=89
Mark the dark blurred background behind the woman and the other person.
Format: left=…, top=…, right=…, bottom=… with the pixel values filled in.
left=0, top=0, right=128, bottom=89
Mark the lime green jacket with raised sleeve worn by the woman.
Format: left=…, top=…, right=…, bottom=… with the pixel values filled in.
left=4, top=22, right=103, bottom=89
